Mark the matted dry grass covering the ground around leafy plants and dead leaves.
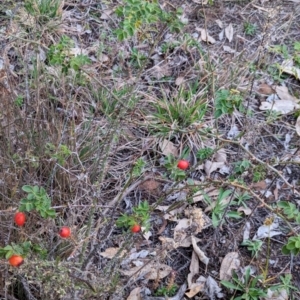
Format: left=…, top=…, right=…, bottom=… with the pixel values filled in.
left=0, top=0, right=300, bottom=300
